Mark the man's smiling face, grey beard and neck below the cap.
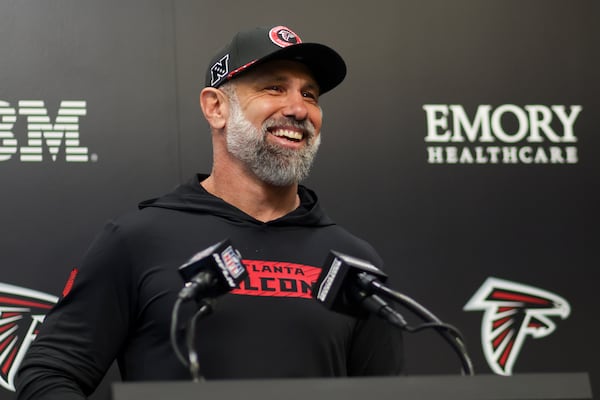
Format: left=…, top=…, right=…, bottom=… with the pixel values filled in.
left=200, top=60, right=322, bottom=222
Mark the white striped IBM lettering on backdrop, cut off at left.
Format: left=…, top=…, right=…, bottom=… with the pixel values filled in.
left=0, top=100, right=97, bottom=162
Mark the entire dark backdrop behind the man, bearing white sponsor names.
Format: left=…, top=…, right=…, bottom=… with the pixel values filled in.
left=0, top=0, right=600, bottom=400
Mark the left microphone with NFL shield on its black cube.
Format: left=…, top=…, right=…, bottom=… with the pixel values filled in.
left=178, top=239, right=248, bottom=301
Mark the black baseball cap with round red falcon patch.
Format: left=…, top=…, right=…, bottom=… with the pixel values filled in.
left=206, top=25, right=346, bottom=94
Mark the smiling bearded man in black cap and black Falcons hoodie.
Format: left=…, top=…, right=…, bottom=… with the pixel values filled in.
left=17, top=26, right=401, bottom=400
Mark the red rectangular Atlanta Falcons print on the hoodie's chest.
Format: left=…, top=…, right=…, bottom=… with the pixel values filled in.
left=231, top=260, right=321, bottom=299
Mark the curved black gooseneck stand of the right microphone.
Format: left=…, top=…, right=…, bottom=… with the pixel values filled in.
left=358, top=272, right=475, bottom=376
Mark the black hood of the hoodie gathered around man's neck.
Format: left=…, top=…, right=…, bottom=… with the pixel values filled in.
left=138, top=174, right=335, bottom=226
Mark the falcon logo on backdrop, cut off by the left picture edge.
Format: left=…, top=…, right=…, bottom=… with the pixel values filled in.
left=0, top=283, right=58, bottom=391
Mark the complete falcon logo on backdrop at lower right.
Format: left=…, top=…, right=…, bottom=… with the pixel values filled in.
left=464, top=278, right=571, bottom=375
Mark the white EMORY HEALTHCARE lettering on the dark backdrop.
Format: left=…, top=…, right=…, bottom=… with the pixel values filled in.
left=423, top=104, right=582, bottom=164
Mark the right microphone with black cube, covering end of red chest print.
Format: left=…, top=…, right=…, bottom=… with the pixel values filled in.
left=313, top=250, right=406, bottom=327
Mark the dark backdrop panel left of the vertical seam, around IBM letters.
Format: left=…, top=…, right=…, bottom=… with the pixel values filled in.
left=0, top=1, right=179, bottom=399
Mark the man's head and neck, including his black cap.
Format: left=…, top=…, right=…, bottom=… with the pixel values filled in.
left=200, top=26, right=346, bottom=222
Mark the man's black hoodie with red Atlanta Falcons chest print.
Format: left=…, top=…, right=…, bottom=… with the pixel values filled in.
left=17, top=175, right=402, bottom=400
